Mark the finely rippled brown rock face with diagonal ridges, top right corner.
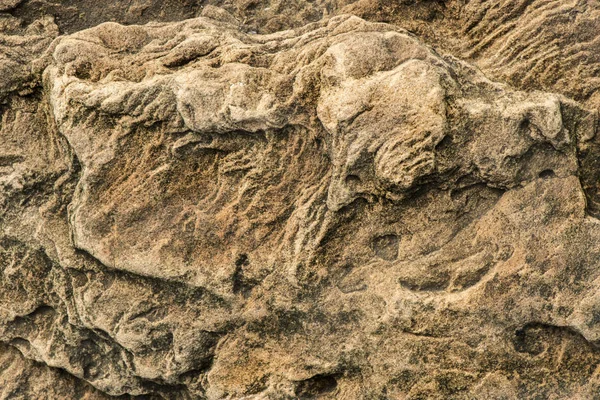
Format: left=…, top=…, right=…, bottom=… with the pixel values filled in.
left=464, top=0, right=600, bottom=107
